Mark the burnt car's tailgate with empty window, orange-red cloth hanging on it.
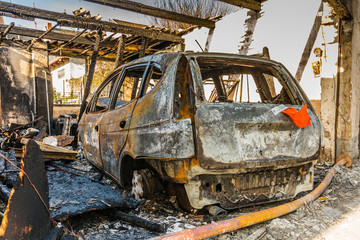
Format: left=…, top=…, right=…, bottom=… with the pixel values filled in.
left=192, top=56, right=321, bottom=169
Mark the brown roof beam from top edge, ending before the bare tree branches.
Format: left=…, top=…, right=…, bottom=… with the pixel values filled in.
left=85, top=0, right=215, bottom=28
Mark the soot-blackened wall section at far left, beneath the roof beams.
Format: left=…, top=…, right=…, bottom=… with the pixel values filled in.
left=0, top=41, right=52, bottom=128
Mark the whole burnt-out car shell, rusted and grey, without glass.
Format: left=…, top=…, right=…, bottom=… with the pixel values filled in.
left=79, top=53, right=322, bottom=209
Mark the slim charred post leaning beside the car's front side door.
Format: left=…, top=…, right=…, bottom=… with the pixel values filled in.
left=78, top=31, right=101, bottom=122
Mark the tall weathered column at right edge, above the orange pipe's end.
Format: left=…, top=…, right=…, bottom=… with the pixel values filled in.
left=335, top=12, right=360, bottom=157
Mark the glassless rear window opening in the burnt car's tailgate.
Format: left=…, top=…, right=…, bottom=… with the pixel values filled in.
left=197, top=57, right=296, bottom=104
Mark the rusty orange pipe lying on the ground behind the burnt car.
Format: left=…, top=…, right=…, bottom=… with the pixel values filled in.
left=151, top=154, right=352, bottom=240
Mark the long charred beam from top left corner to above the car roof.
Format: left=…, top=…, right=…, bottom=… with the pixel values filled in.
left=0, top=1, right=184, bottom=42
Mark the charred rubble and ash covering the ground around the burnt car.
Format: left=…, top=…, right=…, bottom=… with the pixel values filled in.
left=0, top=113, right=360, bottom=240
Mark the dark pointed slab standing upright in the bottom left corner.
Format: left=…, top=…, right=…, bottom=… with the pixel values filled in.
left=0, top=140, right=51, bottom=239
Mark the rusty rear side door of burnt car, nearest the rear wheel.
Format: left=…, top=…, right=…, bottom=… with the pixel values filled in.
left=100, top=63, right=149, bottom=179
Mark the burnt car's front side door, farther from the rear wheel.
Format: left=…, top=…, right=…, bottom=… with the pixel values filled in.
left=79, top=70, right=120, bottom=168
